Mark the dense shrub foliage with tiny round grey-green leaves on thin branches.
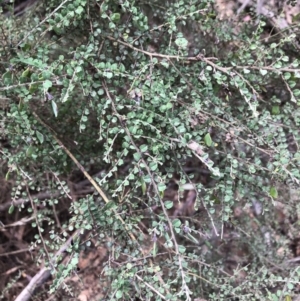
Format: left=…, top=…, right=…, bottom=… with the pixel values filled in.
left=0, top=0, right=300, bottom=300
